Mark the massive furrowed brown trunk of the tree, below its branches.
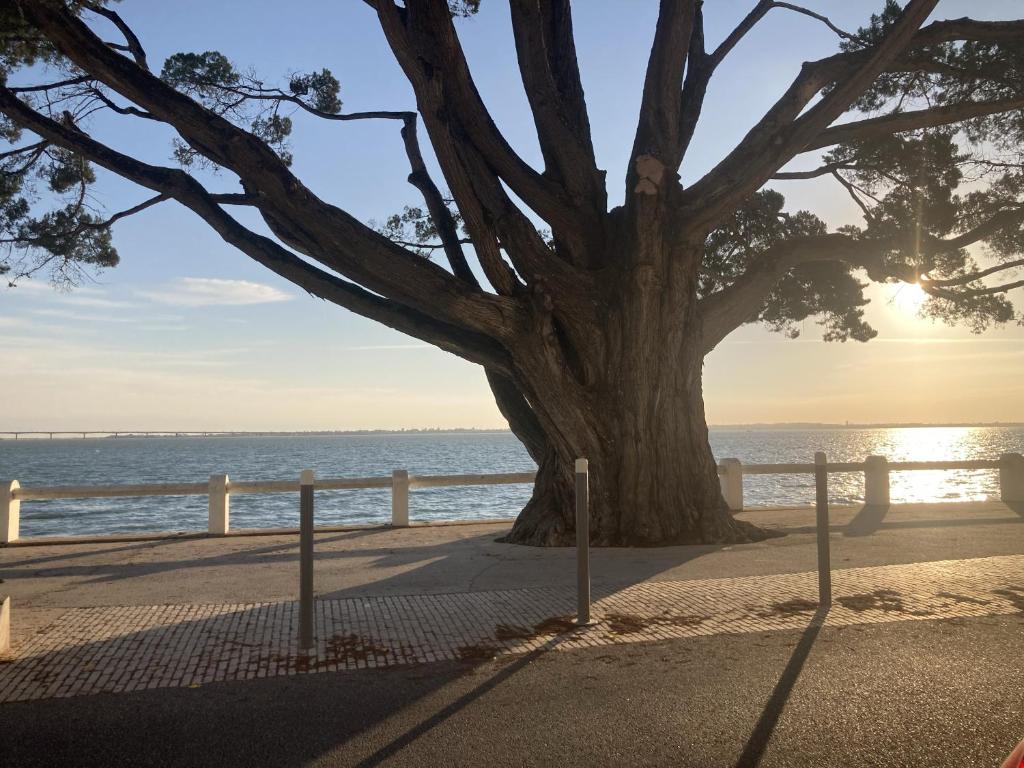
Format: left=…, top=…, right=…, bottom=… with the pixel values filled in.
left=505, top=234, right=767, bottom=546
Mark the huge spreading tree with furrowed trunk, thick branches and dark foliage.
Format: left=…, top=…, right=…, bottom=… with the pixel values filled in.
left=0, top=0, right=1024, bottom=545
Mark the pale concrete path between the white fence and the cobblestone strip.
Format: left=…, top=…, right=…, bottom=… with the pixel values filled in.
left=0, top=502, right=1024, bottom=609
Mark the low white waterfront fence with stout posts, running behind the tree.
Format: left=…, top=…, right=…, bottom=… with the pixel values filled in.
left=0, top=454, right=1024, bottom=544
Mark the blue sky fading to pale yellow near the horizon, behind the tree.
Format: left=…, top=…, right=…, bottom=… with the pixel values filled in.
left=0, top=0, right=1024, bottom=431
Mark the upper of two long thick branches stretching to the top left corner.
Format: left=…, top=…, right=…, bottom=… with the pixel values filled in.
left=26, top=3, right=515, bottom=336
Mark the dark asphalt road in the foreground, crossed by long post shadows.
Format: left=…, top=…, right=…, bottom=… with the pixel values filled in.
left=0, top=613, right=1024, bottom=768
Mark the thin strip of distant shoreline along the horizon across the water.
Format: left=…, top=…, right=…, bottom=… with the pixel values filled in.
left=0, top=422, right=1024, bottom=440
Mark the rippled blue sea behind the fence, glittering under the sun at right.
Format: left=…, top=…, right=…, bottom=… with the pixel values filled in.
left=0, top=427, right=1024, bottom=536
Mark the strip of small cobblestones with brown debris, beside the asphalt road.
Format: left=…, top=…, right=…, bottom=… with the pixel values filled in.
left=0, top=555, right=1024, bottom=701
